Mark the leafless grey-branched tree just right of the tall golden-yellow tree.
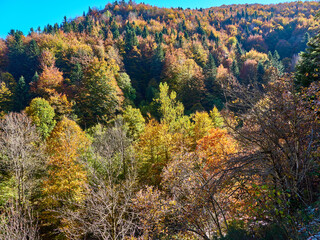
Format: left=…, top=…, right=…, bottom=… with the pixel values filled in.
left=61, top=123, right=137, bottom=240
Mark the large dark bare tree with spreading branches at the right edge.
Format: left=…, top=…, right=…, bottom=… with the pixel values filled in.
left=225, top=77, right=320, bottom=210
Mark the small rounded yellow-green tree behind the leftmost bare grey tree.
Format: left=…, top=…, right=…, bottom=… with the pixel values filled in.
left=26, top=98, right=56, bottom=139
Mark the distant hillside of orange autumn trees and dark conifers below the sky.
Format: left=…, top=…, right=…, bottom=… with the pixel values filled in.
left=0, top=2, right=319, bottom=119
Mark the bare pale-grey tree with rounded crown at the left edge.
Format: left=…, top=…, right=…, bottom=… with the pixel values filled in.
left=0, top=113, right=42, bottom=207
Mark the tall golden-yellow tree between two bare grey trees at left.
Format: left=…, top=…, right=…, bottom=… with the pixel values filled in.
left=41, top=117, right=89, bottom=237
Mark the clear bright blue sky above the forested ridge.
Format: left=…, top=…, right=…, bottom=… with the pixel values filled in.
left=0, top=0, right=298, bottom=38
